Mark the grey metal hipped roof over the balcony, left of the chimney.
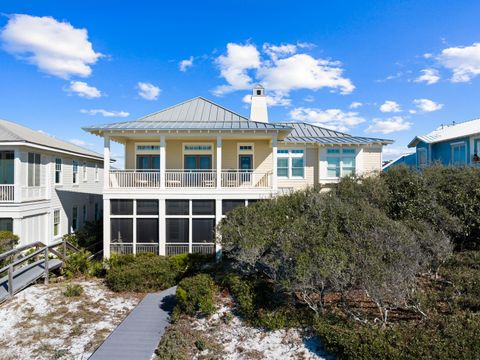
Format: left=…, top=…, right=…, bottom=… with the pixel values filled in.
left=83, top=97, right=290, bottom=133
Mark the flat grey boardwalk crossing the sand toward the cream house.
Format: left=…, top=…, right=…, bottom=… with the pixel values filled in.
left=90, top=287, right=176, bottom=360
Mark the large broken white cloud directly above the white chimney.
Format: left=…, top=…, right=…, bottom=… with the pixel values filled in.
left=213, top=43, right=355, bottom=98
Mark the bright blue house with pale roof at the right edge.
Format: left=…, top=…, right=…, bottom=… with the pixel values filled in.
left=408, top=119, right=480, bottom=168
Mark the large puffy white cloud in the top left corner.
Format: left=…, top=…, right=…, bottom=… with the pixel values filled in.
left=0, top=14, right=102, bottom=79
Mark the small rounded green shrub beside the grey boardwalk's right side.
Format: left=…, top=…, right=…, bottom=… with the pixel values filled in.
left=175, top=274, right=215, bottom=316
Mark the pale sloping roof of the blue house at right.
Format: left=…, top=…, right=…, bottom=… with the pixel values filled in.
left=408, top=119, right=480, bottom=147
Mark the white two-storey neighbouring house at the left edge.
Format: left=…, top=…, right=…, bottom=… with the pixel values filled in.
left=0, top=120, right=104, bottom=245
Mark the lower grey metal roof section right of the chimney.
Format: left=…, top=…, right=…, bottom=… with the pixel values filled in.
left=280, top=122, right=393, bottom=145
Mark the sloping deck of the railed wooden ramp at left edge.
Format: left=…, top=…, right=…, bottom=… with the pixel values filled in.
left=0, top=259, right=62, bottom=303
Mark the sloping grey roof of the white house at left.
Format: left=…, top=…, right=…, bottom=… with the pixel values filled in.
left=0, top=119, right=103, bottom=160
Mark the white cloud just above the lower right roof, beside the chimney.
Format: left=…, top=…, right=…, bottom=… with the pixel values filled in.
left=289, top=107, right=365, bottom=131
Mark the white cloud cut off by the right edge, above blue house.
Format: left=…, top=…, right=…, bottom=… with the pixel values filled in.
left=437, top=43, right=480, bottom=82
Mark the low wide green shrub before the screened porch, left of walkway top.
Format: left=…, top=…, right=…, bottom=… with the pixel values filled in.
left=105, top=254, right=183, bottom=292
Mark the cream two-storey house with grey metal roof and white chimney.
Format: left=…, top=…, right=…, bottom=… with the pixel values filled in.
left=84, top=86, right=392, bottom=257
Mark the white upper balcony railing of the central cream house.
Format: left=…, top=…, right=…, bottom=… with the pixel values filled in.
left=109, top=170, right=272, bottom=189
